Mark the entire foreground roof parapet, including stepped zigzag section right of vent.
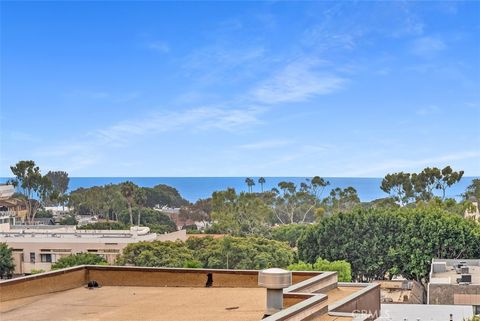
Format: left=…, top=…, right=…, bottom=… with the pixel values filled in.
left=0, top=265, right=380, bottom=321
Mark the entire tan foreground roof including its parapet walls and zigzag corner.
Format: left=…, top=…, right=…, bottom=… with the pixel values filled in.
left=0, top=266, right=380, bottom=321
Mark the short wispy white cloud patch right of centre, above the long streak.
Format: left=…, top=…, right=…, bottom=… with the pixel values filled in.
left=252, top=59, right=346, bottom=104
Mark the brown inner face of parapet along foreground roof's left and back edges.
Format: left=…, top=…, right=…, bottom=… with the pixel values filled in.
left=0, top=265, right=319, bottom=302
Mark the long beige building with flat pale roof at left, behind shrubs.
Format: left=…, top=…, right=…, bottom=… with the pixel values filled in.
left=0, top=218, right=187, bottom=274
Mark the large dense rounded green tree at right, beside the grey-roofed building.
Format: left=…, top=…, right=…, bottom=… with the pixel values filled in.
left=298, top=207, right=480, bottom=282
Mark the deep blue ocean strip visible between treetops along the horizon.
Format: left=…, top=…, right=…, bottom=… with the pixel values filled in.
left=0, top=177, right=476, bottom=202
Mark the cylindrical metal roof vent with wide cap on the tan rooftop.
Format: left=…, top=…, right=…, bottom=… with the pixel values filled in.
left=258, top=268, right=292, bottom=317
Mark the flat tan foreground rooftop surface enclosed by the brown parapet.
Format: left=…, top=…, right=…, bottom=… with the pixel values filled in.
left=0, top=286, right=266, bottom=321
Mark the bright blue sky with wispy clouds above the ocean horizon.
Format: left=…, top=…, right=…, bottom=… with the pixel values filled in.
left=0, top=1, right=480, bottom=177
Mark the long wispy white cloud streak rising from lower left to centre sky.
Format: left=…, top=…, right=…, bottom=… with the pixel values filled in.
left=36, top=107, right=264, bottom=174
